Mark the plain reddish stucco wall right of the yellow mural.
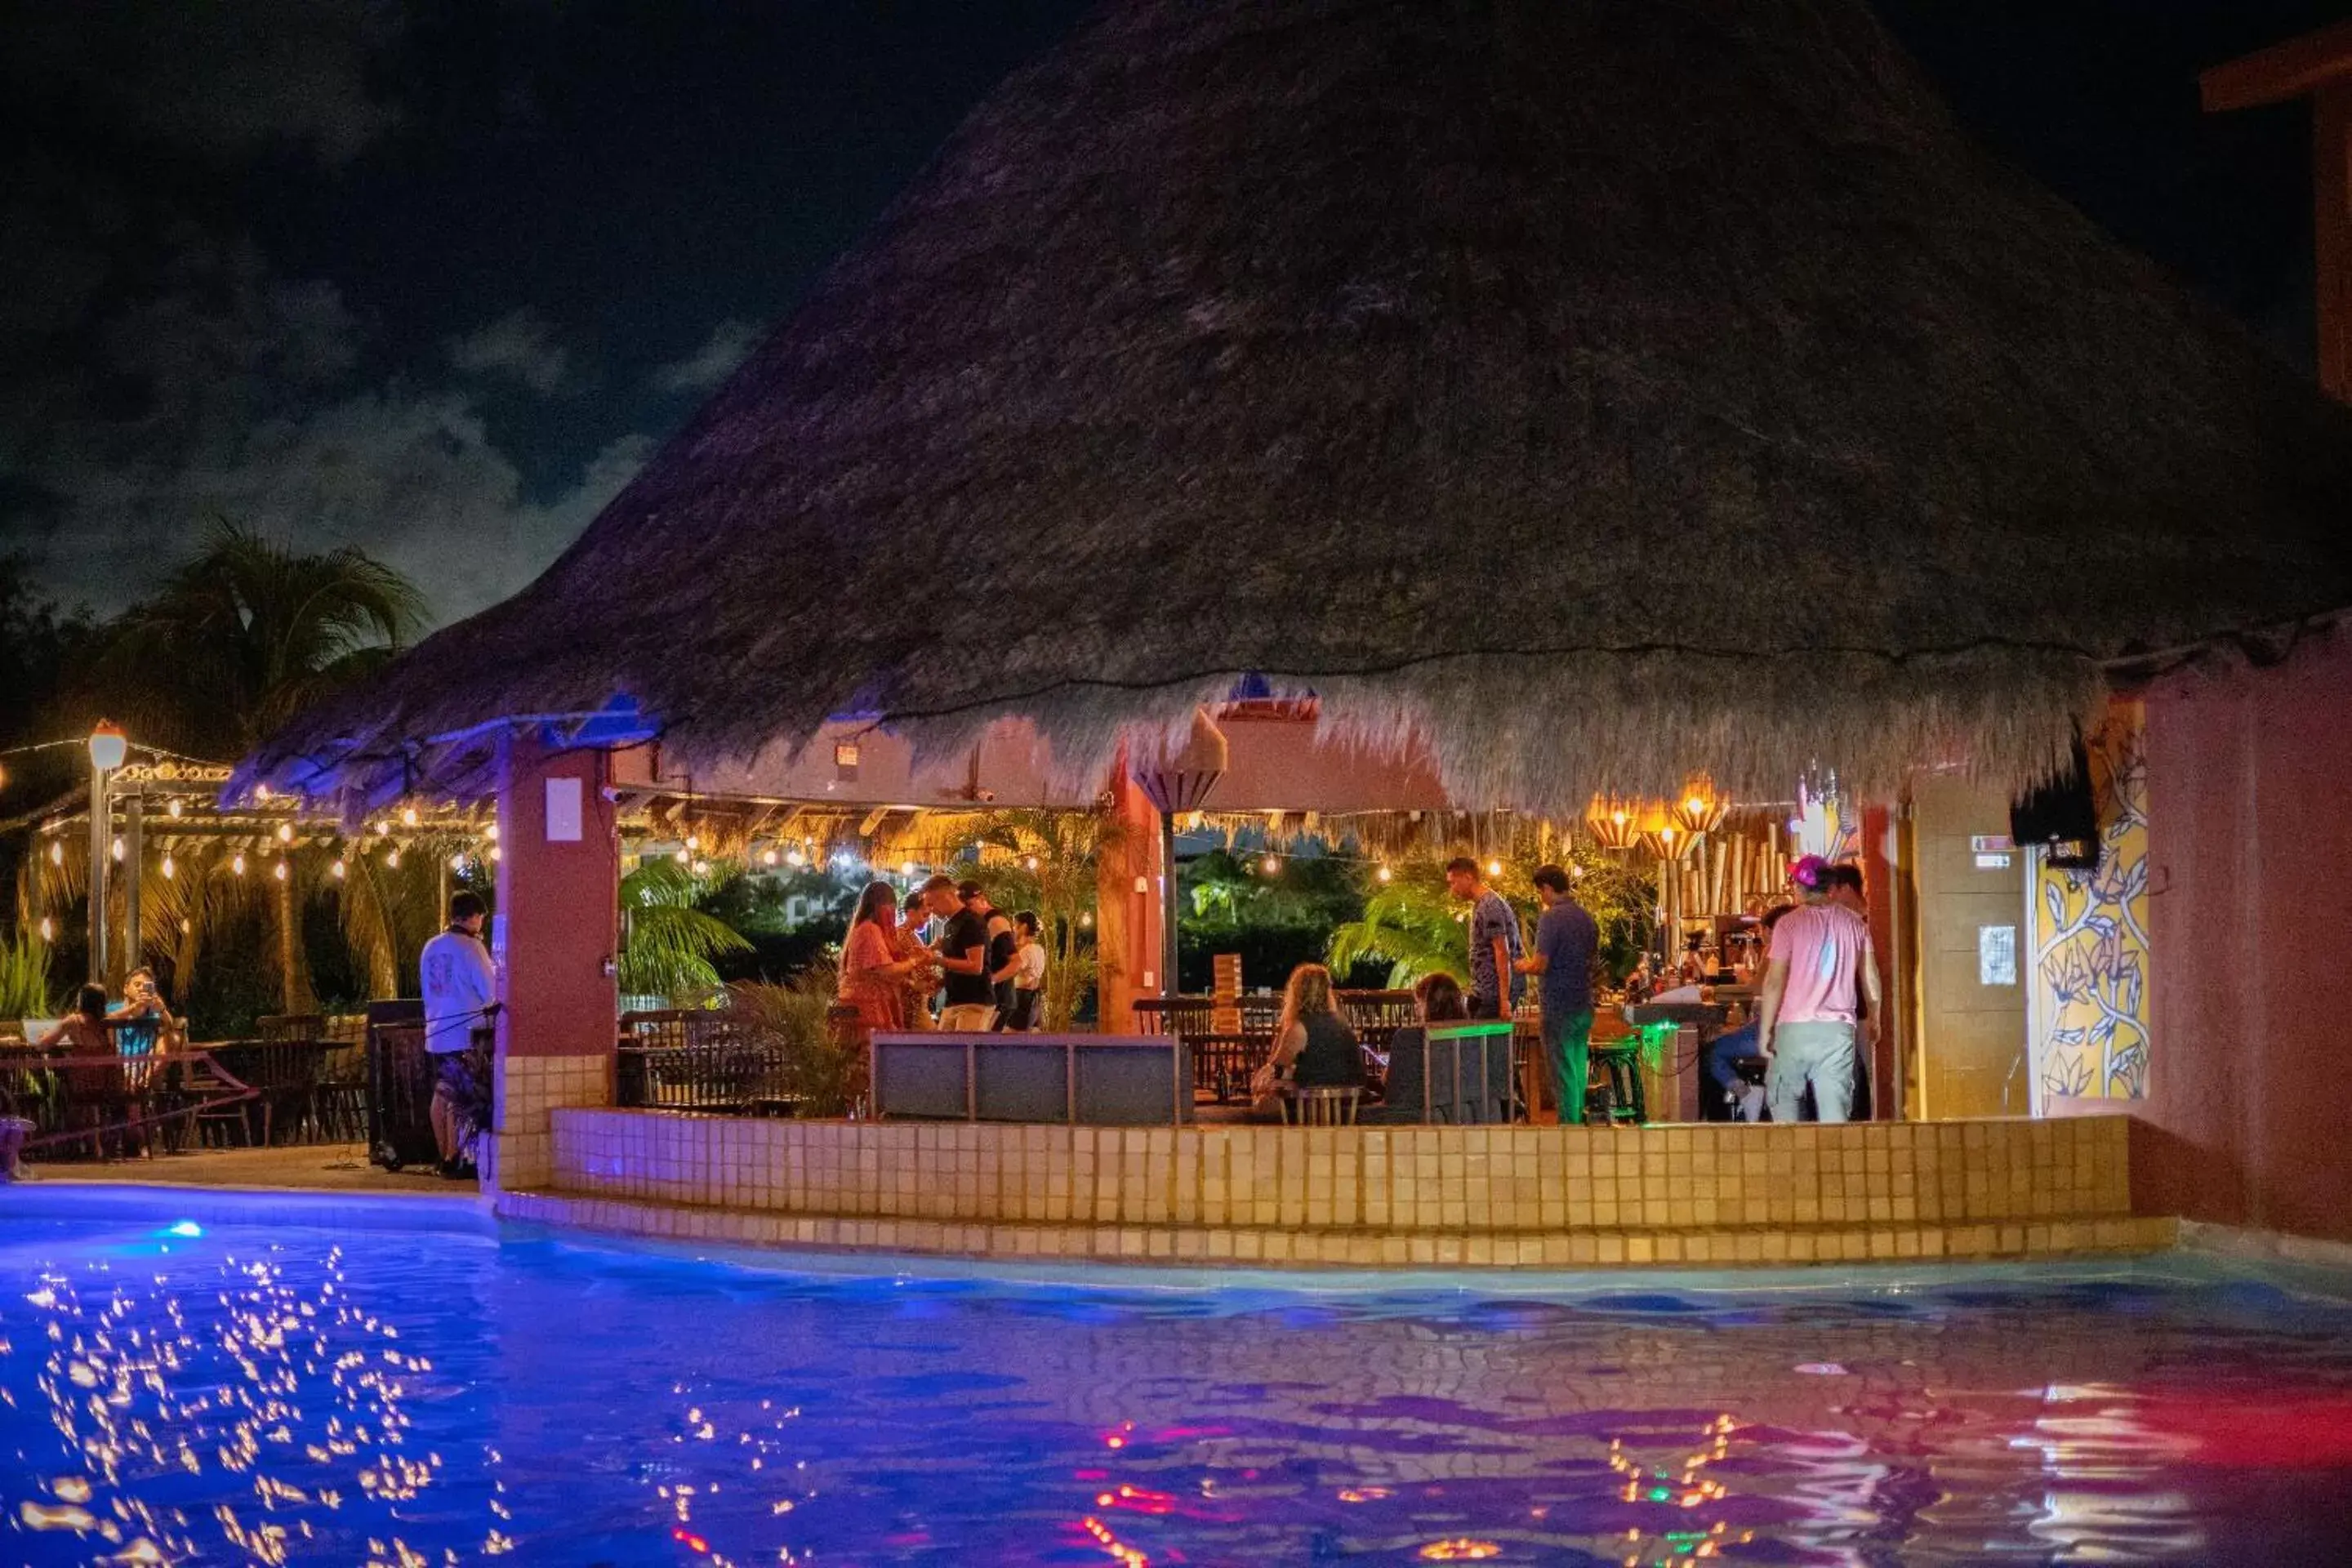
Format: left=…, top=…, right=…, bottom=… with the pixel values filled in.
left=2131, top=637, right=2352, bottom=1241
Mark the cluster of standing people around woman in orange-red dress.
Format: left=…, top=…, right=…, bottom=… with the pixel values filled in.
left=840, top=877, right=1047, bottom=1032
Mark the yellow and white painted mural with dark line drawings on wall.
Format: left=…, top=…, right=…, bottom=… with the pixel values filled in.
left=2032, top=703, right=2147, bottom=1100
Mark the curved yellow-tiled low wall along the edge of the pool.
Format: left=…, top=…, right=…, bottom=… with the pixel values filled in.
left=499, top=1107, right=2173, bottom=1267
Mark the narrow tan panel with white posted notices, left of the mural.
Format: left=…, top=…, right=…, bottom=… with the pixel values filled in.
left=1912, top=776, right=2032, bottom=1121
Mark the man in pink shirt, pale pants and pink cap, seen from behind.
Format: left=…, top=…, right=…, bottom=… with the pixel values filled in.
left=1757, top=856, right=1886, bottom=1121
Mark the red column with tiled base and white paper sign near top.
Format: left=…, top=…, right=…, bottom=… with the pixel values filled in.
left=492, top=731, right=621, bottom=1187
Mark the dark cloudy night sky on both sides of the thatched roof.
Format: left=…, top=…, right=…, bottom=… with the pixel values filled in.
left=0, top=0, right=2352, bottom=618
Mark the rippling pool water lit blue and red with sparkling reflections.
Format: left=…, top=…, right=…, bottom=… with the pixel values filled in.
left=0, top=1220, right=2352, bottom=1568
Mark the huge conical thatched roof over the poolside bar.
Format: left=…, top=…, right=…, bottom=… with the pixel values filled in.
left=234, top=0, right=2352, bottom=806
